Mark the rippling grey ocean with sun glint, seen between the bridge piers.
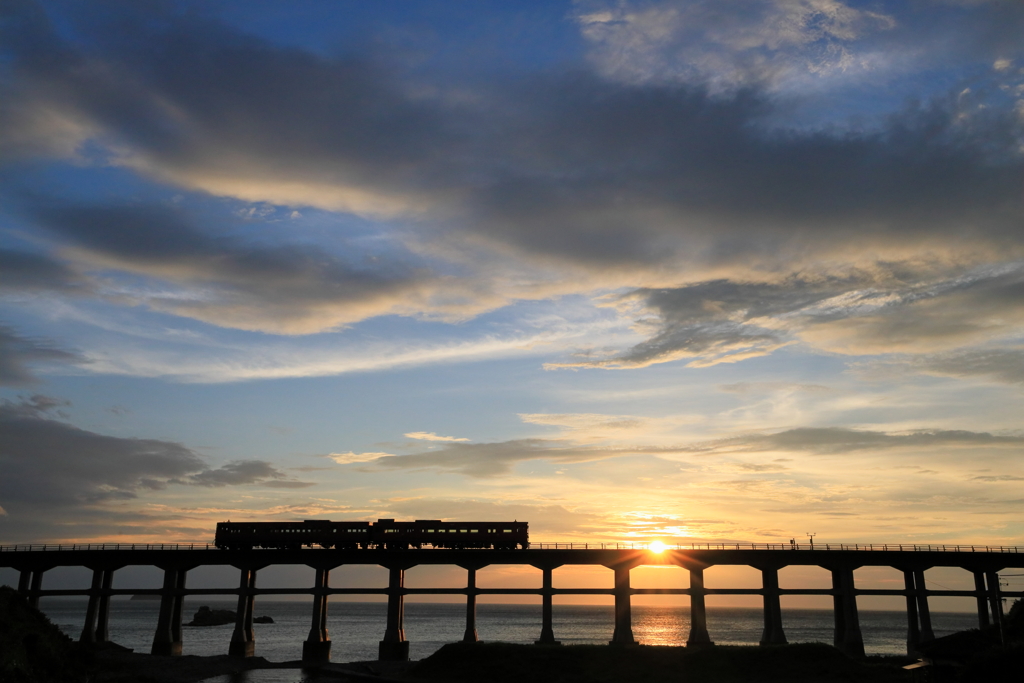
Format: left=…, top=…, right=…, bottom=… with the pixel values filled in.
left=39, top=597, right=978, bottom=683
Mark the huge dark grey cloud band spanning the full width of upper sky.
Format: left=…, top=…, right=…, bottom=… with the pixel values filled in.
left=2, top=0, right=1024, bottom=265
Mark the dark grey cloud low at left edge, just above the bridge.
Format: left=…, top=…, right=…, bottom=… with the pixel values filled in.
left=0, top=396, right=311, bottom=512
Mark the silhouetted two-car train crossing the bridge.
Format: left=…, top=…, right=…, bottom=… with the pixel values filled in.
left=214, top=519, right=529, bottom=550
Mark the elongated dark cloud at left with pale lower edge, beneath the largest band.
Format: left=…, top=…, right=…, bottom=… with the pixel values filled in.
left=23, top=200, right=426, bottom=334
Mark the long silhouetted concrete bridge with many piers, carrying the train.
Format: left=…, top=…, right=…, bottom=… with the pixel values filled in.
left=0, top=544, right=1024, bottom=661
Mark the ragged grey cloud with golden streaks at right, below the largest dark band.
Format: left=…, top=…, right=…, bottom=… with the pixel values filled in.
left=553, top=264, right=1024, bottom=368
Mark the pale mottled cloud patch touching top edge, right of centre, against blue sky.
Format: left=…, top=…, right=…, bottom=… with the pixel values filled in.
left=575, top=0, right=897, bottom=88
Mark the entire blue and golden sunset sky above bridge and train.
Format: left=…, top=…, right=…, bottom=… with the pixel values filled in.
left=0, top=0, right=1024, bottom=561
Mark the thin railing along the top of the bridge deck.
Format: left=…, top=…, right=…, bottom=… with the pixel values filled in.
left=0, top=541, right=1024, bottom=553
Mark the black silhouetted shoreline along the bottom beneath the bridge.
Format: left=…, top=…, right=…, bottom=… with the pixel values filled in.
left=6, top=587, right=1024, bottom=683
